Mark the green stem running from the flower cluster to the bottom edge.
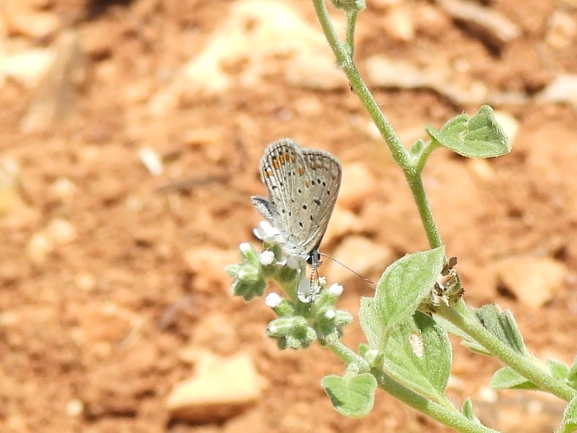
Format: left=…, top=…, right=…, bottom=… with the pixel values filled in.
left=327, top=341, right=496, bottom=433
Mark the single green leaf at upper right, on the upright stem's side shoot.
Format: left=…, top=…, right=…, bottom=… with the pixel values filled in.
left=425, top=105, right=511, bottom=158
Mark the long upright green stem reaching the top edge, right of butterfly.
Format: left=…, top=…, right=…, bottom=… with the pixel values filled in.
left=312, top=0, right=443, bottom=248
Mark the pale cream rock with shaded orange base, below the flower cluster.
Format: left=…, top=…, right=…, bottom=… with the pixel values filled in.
left=166, top=352, right=266, bottom=423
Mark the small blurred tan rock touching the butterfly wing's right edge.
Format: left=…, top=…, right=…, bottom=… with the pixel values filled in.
left=338, top=163, right=378, bottom=211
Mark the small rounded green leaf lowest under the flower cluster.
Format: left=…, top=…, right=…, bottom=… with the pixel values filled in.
left=321, top=373, right=377, bottom=417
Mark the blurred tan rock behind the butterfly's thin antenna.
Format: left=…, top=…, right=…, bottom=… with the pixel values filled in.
left=325, top=236, right=393, bottom=283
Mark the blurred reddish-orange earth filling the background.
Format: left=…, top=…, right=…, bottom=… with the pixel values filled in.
left=0, top=0, right=577, bottom=433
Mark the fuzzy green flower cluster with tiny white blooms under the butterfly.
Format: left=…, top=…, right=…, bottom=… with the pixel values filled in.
left=227, top=222, right=353, bottom=349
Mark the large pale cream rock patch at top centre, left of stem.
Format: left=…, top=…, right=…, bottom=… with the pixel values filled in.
left=150, top=0, right=348, bottom=113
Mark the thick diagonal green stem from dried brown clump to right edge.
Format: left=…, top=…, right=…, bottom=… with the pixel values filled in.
left=437, top=307, right=577, bottom=401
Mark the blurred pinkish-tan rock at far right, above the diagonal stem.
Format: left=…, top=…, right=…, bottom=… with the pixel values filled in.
left=495, top=256, right=567, bottom=308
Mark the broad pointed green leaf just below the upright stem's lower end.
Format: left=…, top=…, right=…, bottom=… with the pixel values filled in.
left=375, top=247, right=445, bottom=339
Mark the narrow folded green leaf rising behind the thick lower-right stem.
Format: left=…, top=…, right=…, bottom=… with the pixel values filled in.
left=475, top=305, right=530, bottom=356
